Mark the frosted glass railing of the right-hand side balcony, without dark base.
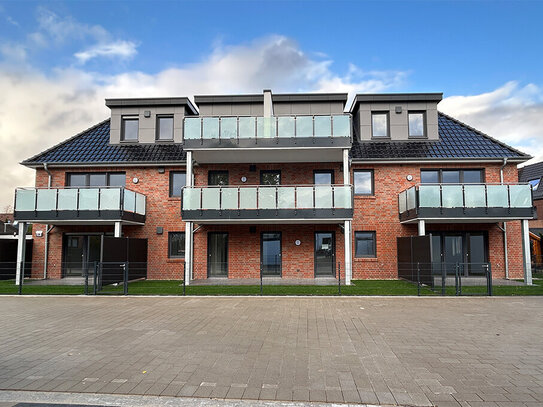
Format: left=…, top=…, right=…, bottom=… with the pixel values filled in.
left=398, top=183, right=533, bottom=213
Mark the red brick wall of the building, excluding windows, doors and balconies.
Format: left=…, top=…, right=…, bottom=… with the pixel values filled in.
left=28, top=163, right=522, bottom=279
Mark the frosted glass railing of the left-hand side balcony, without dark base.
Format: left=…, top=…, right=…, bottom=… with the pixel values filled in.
left=14, top=187, right=146, bottom=217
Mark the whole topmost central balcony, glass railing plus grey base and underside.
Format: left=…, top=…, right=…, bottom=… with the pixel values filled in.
left=184, top=114, right=352, bottom=163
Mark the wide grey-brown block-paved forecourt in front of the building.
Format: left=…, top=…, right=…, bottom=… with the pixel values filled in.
left=0, top=297, right=543, bottom=407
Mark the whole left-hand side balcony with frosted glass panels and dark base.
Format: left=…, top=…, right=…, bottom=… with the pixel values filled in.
left=14, top=187, right=146, bottom=225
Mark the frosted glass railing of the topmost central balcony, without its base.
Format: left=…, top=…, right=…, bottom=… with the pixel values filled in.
left=183, top=114, right=352, bottom=140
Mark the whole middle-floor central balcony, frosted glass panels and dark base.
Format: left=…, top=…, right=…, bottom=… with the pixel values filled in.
left=181, top=185, right=353, bottom=223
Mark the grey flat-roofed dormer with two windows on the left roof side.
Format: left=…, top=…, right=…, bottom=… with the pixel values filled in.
left=106, top=97, right=198, bottom=144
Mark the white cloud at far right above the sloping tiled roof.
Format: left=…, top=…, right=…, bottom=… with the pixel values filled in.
left=439, top=81, right=543, bottom=166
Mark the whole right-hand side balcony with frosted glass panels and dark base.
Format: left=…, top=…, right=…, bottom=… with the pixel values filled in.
left=398, top=184, right=535, bottom=223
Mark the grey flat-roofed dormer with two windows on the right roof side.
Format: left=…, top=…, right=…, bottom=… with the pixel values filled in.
left=351, top=93, right=443, bottom=142
